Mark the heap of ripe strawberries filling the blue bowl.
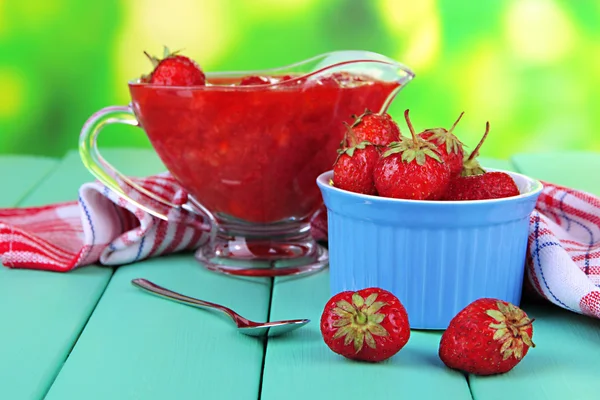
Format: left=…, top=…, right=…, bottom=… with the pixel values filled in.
left=332, top=110, right=519, bottom=200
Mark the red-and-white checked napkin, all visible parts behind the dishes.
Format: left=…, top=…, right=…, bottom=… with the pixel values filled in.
left=0, top=173, right=600, bottom=318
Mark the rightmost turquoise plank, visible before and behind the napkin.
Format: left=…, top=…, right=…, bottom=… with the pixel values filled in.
left=469, top=152, right=600, bottom=400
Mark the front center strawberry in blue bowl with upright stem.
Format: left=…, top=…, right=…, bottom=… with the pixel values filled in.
left=374, top=110, right=450, bottom=200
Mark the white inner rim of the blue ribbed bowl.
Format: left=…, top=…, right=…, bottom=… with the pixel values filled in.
left=317, top=167, right=544, bottom=207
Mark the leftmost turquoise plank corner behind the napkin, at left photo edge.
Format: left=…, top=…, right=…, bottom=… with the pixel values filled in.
left=0, top=155, right=59, bottom=208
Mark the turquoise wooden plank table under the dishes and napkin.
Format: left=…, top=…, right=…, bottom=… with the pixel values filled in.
left=0, top=149, right=600, bottom=400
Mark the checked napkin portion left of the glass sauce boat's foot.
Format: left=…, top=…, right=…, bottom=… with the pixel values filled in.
left=0, top=173, right=208, bottom=272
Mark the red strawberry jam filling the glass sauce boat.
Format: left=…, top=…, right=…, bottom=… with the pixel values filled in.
left=130, top=74, right=398, bottom=223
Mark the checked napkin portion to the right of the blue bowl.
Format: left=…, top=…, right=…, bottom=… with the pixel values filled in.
left=526, top=182, right=600, bottom=318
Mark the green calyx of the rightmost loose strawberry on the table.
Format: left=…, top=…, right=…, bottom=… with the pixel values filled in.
left=486, top=301, right=535, bottom=360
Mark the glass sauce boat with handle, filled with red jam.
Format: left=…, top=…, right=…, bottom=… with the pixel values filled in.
left=79, top=51, right=414, bottom=276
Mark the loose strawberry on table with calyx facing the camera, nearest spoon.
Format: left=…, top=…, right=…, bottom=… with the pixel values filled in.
left=321, top=288, right=410, bottom=362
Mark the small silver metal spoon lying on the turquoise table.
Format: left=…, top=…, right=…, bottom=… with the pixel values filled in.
left=131, top=278, right=310, bottom=337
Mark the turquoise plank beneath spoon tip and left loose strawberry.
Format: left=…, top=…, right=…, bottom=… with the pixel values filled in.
left=261, top=270, right=471, bottom=400
